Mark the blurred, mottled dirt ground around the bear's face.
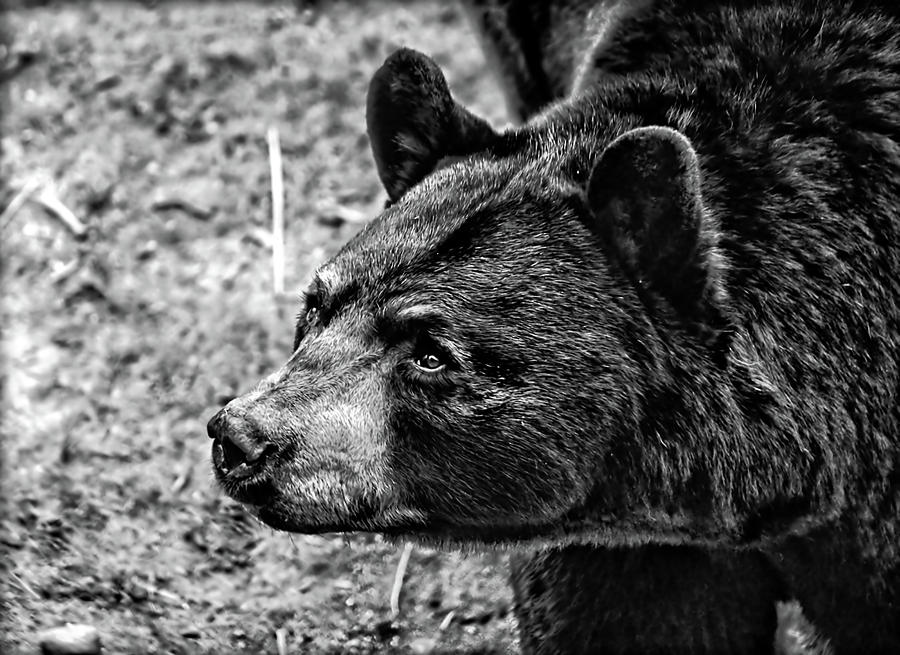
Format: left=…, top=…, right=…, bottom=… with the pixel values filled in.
left=0, top=1, right=516, bottom=654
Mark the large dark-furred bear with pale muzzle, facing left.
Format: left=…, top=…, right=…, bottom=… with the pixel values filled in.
left=207, top=0, right=900, bottom=655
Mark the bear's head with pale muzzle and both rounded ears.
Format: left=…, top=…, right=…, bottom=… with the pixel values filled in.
left=209, top=49, right=729, bottom=543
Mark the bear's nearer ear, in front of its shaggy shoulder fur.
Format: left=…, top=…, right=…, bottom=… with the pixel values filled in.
left=588, top=127, right=731, bottom=354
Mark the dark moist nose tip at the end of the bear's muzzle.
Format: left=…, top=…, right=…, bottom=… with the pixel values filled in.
left=206, top=407, right=272, bottom=478
